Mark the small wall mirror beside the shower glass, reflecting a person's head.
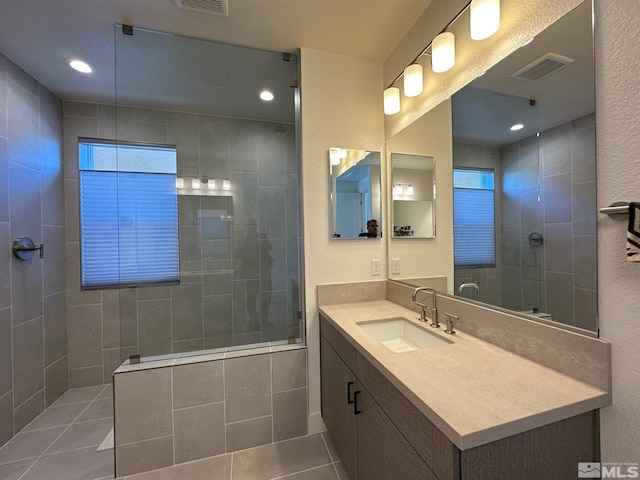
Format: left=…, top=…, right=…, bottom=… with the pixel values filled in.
left=329, top=147, right=382, bottom=240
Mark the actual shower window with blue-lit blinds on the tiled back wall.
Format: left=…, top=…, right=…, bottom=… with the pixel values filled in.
left=78, top=139, right=180, bottom=290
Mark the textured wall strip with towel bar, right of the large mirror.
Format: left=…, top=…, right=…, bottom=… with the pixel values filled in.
left=595, top=0, right=640, bottom=462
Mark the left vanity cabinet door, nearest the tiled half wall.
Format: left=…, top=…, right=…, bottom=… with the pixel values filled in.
left=320, top=337, right=358, bottom=480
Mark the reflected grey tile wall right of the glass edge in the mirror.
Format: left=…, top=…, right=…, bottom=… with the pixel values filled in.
left=540, top=115, right=597, bottom=331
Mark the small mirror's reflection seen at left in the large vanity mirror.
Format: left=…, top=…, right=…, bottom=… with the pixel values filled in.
left=391, top=153, right=435, bottom=238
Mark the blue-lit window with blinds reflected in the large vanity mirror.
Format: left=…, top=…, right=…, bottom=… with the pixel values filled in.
left=453, top=168, right=496, bottom=268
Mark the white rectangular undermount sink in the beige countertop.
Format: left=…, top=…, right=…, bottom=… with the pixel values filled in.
left=357, top=317, right=453, bottom=353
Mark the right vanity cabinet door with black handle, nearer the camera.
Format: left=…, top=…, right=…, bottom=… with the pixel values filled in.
left=358, top=386, right=438, bottom=480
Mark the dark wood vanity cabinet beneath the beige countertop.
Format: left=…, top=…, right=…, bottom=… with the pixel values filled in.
left=320, top=316, right=600, bottom=480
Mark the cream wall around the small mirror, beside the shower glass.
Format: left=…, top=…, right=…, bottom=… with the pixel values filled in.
left=300, top=49, right=388, bottom=433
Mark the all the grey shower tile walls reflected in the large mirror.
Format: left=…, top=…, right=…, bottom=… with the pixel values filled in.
left=454, top=115, right=597, bottom=330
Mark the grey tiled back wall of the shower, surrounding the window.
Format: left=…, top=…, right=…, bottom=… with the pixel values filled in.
left=64, top=102, right=300, bottom=387
